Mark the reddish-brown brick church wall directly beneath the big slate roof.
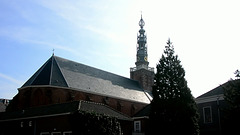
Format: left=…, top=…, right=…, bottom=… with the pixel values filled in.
left=10, top=86, right=147, bottom=116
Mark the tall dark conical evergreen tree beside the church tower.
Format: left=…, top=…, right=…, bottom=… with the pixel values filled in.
left=149, top=39, right=199, bottom=135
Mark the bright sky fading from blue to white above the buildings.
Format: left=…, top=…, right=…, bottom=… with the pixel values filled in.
left=0, top=0, right=240, bottom=98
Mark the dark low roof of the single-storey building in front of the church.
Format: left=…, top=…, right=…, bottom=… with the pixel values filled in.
left=0, top=101, right=132, bottom=121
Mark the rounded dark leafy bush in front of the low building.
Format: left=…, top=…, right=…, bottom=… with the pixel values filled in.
left=72, top=111, right=121, bottom=135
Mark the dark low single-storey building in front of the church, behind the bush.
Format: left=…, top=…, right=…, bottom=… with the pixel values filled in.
left=0, top=101, right=132, bottom=135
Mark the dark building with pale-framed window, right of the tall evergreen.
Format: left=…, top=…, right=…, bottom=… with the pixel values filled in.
left=195, top=80, right=236, bottom=135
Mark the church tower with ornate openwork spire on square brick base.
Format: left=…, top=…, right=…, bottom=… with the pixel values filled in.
left=130, top=15, right=154, bottom=92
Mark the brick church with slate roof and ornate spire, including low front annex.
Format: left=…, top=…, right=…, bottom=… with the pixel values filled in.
left=0, top=17, right=154, bottom=135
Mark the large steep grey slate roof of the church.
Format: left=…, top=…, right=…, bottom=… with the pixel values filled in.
left=22, top=55, right=150, bottom=104
